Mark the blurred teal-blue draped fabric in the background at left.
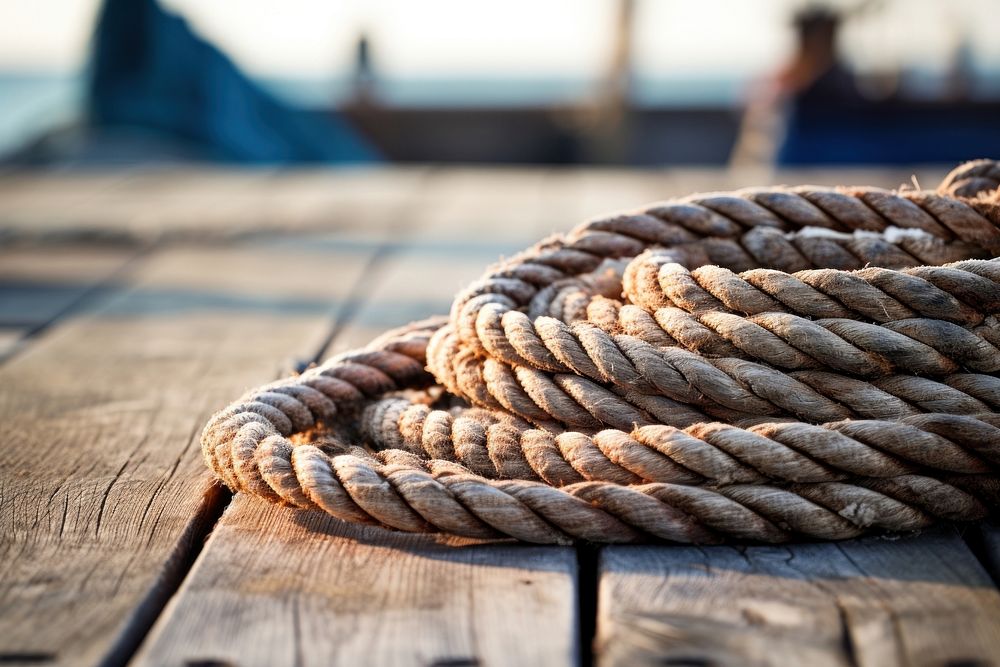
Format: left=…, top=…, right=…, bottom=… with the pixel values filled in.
left=89, top=0, right=378, bottom=163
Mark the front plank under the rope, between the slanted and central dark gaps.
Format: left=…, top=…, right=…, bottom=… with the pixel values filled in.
left=134, top=495, right=577, bottom=667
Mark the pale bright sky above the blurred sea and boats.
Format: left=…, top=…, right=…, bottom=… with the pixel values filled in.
left=0, top=0, right=1000, bottom=78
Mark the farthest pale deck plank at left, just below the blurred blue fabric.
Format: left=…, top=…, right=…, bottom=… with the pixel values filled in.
left=0, top=167, right=424, bottom=240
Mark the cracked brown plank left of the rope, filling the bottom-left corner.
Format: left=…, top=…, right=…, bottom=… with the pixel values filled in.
left=0, top=245, right=374, bottom=665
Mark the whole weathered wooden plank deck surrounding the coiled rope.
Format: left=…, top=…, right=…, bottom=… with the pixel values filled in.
left=0, top=169, right=1000, bottom=667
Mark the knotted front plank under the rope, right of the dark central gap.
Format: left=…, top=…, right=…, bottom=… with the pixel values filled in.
left=596, top=528, right=1000, bottom=666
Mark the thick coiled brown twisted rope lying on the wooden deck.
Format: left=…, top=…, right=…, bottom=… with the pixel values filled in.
left=202, top=160, right=1000, bottom=544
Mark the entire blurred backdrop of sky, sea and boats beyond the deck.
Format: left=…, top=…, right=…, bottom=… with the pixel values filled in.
left=0, top=0, right=1000, bottom=166
